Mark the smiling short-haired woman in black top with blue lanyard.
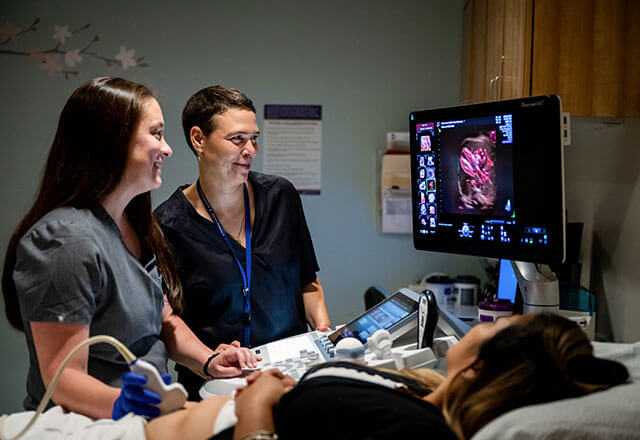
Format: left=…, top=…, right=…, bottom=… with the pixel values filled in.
left=155, top=86, right=330, bottom=399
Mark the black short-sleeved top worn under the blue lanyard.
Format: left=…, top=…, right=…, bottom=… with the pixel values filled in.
left=154, top=172, right=319, bottom=398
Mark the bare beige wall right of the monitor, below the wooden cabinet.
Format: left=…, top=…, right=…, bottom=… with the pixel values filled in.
left=565, top=118, right=640, bottom=342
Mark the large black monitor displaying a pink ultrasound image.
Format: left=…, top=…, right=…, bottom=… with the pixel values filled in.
left=409, top=96, right=565, bottom=264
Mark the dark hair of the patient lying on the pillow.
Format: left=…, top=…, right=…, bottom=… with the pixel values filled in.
left=444, top=314, right=629, bottom=439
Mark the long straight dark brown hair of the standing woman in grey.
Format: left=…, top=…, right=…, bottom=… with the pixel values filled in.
left=2, top=77, right=182, bottom=331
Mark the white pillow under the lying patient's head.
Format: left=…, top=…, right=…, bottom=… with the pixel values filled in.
left=473, top=342, right=640, bottom=440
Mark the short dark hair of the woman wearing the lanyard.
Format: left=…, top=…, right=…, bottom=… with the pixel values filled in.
left=182, top=85, right=256, bottom=155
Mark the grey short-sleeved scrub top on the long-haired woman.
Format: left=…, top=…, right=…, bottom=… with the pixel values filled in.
left=13, top=205, right=167, bottom=410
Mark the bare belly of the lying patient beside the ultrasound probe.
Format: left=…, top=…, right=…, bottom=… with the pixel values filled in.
left=144, top=396, right=230, bottom=440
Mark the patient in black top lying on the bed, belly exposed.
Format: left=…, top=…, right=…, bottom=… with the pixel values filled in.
left=0, top=314, right=629, bottom=440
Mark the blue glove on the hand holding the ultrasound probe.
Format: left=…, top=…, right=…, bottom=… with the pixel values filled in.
left=111, top=371, right=171, bottom=420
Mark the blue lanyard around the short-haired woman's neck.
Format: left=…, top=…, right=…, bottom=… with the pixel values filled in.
left=196, top=180, right=251, bottom=347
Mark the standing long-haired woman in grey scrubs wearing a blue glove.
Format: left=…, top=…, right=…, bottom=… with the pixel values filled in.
left=2, top=77, right=255, bottom=418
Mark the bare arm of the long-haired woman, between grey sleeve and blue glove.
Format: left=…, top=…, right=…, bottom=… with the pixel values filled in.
left=30, top=322, right=120, bottom=419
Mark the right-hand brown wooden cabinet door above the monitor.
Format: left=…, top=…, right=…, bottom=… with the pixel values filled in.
left=531, top=0, right=640, bottom=117
